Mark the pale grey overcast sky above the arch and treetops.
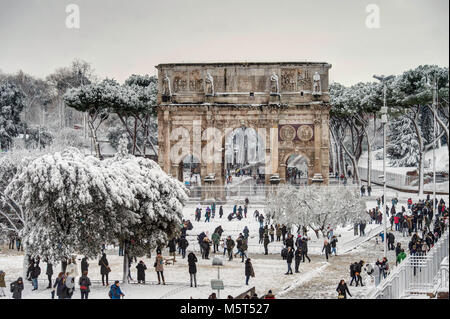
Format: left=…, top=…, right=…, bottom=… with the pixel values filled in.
left=0, top=0, right=449, bottom=85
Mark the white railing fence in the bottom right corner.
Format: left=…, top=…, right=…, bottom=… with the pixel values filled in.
left=367, top=229, right=449, bottom=299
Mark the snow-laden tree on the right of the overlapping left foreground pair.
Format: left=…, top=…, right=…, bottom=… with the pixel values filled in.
left=105, top=136, right=187, bottom=281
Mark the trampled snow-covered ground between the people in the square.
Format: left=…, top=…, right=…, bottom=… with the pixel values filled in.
left=0, top=192, right=448, bottom=299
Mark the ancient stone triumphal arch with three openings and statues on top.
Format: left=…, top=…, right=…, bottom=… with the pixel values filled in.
left=156, top=62, right=331, bottom=194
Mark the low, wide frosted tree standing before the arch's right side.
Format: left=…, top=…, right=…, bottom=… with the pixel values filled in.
left=266, top=186, right=369, bottom=238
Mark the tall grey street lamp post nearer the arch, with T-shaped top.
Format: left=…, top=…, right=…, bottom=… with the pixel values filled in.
left=373, top=75, right=394, bottom=257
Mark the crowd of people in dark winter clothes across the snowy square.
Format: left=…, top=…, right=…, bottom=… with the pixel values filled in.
left=0, top=189, right=448, bottom=299
